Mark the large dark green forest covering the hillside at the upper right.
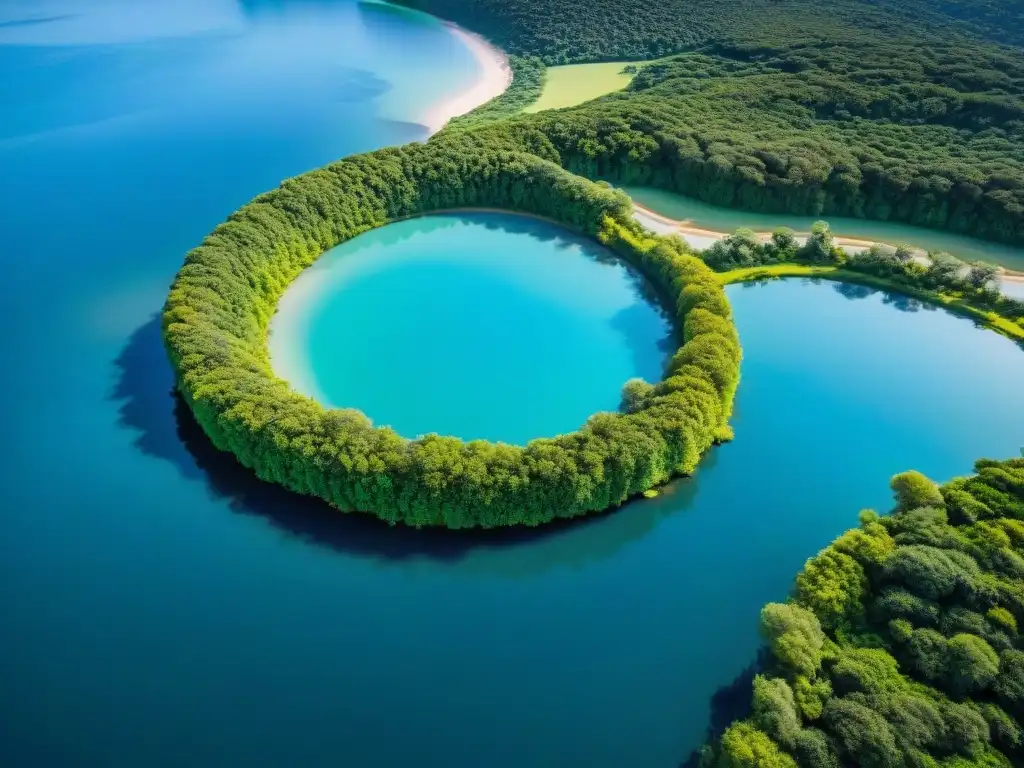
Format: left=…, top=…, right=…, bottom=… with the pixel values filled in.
left=395, top=0, right=1024, bottom=243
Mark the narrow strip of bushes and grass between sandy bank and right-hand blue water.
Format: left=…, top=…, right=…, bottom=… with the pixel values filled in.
left=701, top=221, right=1024, bottom=342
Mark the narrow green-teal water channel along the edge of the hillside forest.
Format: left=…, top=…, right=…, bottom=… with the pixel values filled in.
left=623, top=186, right=1024, bottom=270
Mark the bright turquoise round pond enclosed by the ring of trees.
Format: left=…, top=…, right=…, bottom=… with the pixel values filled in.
left=268, top=212, right=675, bottom=444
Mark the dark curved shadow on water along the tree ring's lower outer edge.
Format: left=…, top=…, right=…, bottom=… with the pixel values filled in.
left=111, top=316, right=714, bottom=575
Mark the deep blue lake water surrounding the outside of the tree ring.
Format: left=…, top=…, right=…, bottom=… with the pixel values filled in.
left=0, top=0, right=1024, bottom=768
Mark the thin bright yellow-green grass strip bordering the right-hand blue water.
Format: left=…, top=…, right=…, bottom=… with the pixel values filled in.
left=717, top=264, right=1024, bottom=344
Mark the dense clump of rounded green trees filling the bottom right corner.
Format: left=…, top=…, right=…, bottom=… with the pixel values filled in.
left=700, top=459, right=1024, bottom=768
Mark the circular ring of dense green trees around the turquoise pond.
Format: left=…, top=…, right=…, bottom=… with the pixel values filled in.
left=163, top=137, right=740, bottom=528
